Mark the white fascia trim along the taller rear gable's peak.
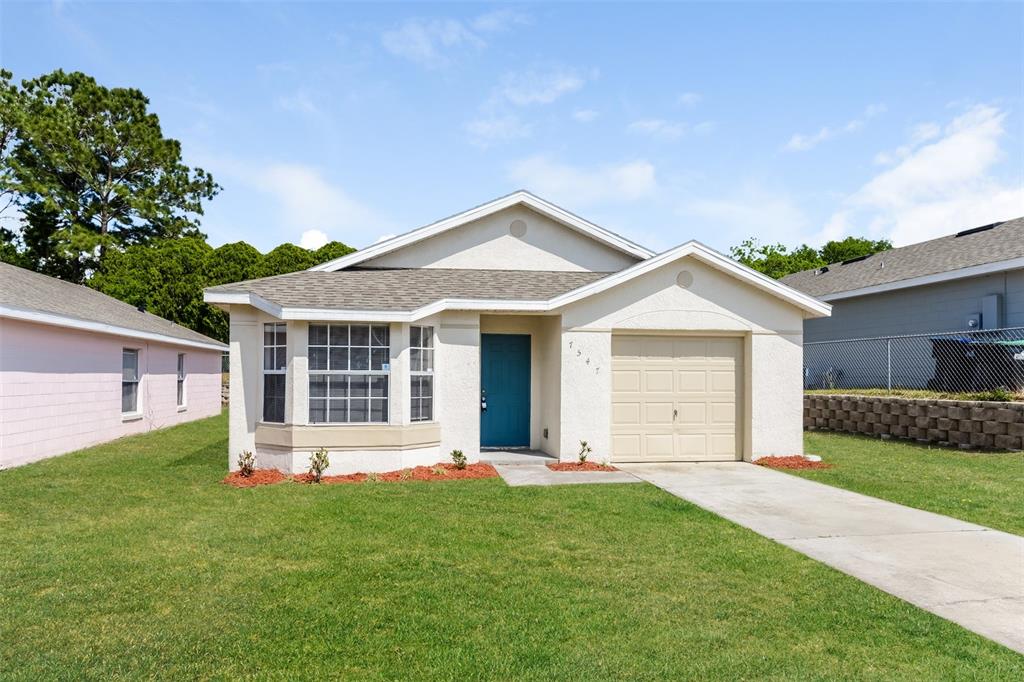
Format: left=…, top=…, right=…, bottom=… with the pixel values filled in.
left=309, top=189, right=654, bottom=272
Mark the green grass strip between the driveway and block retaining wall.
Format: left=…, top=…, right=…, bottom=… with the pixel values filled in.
left=802, top=431, right=1024, bottom=536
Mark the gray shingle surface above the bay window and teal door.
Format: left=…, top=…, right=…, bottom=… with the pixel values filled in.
left=206, top=268, right=610, bottom=311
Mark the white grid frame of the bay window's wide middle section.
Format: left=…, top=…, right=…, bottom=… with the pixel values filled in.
left=306, top=323, right=391, bottom=425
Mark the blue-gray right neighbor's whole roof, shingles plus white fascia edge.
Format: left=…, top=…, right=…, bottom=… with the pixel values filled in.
left=781, top=218, right=1024, bottom=301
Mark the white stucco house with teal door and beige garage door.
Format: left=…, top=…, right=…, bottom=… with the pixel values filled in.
left=205, top=191, right=829, bottom=473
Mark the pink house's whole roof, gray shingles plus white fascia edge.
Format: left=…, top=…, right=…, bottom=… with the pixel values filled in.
left=0, top=263, right=227, bottom=350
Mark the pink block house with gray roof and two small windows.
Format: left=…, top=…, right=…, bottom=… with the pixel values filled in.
left=0, top=263, right=227, bottom=469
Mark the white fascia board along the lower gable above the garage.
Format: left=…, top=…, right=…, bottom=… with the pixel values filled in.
left=550, top=241, right=831, bottom=316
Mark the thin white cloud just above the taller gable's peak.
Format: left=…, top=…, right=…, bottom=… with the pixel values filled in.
left=508, top=156, right=657, bottom=205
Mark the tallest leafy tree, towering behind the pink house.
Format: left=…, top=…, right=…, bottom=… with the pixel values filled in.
left=0, top=70, right=219, bottom=282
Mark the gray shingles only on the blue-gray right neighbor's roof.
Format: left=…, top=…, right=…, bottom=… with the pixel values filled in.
left=782, top=218, right=1024, bottom=296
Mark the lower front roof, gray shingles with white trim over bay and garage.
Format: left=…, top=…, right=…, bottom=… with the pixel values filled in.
left=204, top=242, right=831, bottom=322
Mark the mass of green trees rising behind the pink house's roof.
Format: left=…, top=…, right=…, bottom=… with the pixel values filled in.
left=0, top=70, right=353, bottom=340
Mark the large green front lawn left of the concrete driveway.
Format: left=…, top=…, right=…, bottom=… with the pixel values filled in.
left=0, top=417, right=1024, bottom=680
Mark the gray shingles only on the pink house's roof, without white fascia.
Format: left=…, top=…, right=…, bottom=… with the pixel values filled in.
left=0, top=263, right=227, bottom=349
